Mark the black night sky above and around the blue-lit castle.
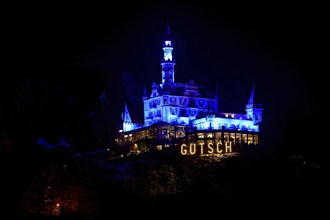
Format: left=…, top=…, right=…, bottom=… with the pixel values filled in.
left=1, top=1, right=325, bottom=146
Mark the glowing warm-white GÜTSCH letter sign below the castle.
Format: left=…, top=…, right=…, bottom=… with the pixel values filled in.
left=180, top=141, right=232, bottom=155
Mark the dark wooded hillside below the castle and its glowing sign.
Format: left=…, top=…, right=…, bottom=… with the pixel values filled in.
left=1, top=146, right=327, bottom=219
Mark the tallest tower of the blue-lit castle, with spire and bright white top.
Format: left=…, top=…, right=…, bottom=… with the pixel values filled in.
left=160, top=26, right=175, bottom=86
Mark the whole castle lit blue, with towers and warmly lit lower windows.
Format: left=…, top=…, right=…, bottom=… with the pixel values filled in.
left=117, top=29, right=263, bottom=154
